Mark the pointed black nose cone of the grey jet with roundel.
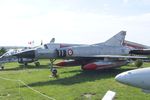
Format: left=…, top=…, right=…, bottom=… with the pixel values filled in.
left=14, top=50, right=36, bottom=58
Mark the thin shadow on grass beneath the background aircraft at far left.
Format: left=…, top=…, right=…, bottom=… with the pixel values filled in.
left=1, top=65, right=49, bottom=71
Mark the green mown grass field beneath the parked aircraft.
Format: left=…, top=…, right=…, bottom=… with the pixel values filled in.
left=0, top=60, right=150, bottom=100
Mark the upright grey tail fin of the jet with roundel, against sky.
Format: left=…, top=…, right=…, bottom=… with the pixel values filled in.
left=104, top=31, right=126, bottom=46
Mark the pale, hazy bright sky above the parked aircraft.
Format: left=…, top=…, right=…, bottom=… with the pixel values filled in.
left=0, top=0, right=150, bottom=46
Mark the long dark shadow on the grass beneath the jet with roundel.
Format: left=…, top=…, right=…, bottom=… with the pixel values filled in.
left=25, top=68, right=135, bottom=87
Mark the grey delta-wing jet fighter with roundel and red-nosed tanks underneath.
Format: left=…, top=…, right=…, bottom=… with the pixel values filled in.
left=8, top=31, right=147, bottom=70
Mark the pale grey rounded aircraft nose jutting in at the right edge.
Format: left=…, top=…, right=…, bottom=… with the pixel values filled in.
left=115, top=68, right=150, bottom=93
